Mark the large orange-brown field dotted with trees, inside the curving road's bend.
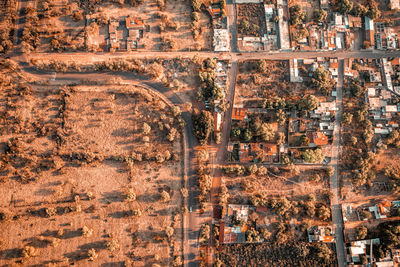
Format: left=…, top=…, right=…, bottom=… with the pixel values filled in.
left=0, top=74, right=182, bottom=266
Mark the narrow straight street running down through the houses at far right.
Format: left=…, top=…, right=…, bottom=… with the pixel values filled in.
left=330, top=59, right=346, bottom=267
